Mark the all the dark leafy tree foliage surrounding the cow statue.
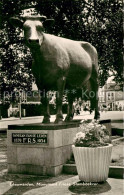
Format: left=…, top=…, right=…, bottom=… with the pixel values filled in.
left=0, top=0, right=123, bottom=103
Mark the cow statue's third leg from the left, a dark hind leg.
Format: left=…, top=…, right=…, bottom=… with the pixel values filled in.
left=65, top=93, right=74, bottom=122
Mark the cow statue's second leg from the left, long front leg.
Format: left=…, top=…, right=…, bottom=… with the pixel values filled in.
left=55, top=78, right=65, bottom=123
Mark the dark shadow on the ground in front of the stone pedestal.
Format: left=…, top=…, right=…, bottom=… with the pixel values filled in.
left=0, top=172, right=73, bottom=195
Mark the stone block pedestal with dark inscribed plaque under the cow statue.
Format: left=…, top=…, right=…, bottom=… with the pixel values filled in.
left=7, top=121, right=80, bottom=176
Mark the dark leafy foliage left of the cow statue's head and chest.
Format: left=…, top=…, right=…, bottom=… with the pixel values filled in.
left=0, top=0, right=33, bottom=99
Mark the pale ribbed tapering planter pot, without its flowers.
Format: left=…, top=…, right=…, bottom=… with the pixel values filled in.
left=72, top=144, right=112, bottom=182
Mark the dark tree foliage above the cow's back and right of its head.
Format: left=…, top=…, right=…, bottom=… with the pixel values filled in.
left=36, top=0, right=123, bottom=87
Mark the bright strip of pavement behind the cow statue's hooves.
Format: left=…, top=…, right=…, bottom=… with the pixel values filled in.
left=0, top=111, right=124, bottom=130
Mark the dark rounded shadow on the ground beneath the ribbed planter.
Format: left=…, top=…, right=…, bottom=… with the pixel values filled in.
left=68, top=181, right=111, bottom=194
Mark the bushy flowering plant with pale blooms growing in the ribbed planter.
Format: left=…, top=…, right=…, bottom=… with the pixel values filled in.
left=73, top=120, right=111, bottom=147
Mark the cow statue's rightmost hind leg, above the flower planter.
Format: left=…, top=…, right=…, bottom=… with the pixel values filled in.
left=90, top=80, right=100, bottom=120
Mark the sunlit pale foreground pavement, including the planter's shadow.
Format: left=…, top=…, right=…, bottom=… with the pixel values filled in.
left=0, top=176, right=124, bottom=195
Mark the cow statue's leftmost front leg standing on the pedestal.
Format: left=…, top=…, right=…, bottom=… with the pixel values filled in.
left=41, top=93, right=50, bottom=123
